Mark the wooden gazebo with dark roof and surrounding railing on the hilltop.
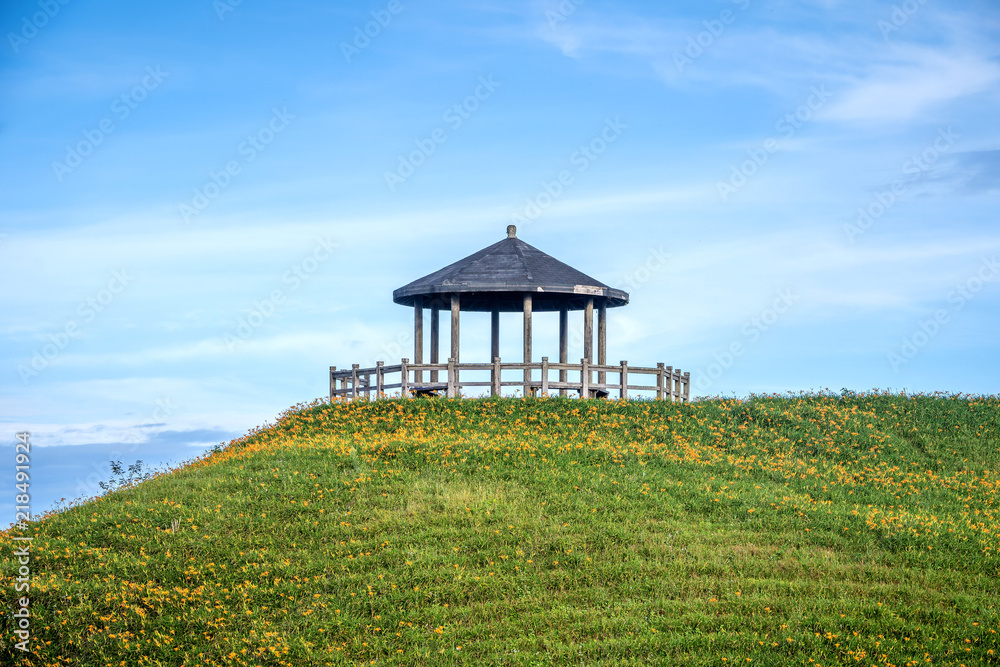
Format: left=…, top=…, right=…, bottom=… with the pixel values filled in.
left=330, top=225, right=690, bottom=400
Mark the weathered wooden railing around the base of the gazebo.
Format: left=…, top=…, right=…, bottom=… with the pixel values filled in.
left=330, top=357, right=691, bottom=402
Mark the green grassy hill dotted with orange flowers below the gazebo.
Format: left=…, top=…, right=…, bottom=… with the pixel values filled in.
left=0, top=394, right=1000, bottom=667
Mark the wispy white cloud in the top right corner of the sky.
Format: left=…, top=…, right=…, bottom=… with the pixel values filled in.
left=534, top=4, right=1000, bottom=123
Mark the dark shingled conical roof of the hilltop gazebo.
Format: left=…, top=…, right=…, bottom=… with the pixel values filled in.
left=392, top=226, right=628, bottom=312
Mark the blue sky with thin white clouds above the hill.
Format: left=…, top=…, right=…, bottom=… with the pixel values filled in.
left=0, top=0, right=1000, bottom=522
